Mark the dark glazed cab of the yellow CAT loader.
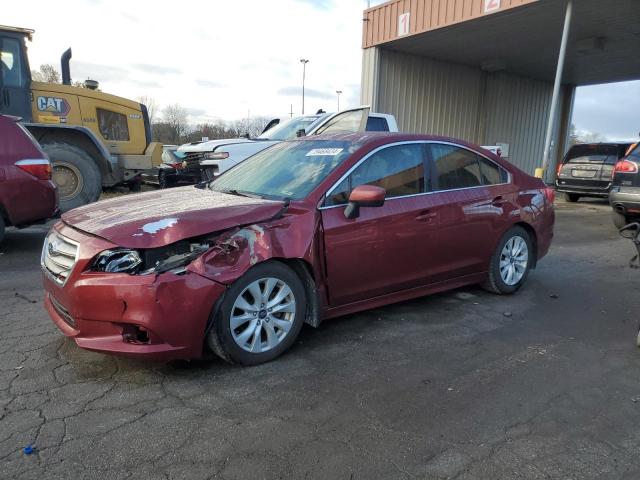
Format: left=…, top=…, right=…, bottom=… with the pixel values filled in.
left=0, top=26, right=33, bottom=122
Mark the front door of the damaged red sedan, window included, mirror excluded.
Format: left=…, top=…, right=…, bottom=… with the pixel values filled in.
left=321, top=142, right=437, bottom=307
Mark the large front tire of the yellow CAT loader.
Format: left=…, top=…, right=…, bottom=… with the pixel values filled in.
left=42, top=142, right=102, bottom=212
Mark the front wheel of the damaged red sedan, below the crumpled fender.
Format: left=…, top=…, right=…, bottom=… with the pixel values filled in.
left=206, top=261, right=307, bottom=365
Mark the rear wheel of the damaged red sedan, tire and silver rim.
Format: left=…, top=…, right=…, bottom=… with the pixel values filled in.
left=482, top=226, right=535, bottom=295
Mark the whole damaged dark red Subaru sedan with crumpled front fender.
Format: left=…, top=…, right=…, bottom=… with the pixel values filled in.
left=42, top=133, right=554, bottom=365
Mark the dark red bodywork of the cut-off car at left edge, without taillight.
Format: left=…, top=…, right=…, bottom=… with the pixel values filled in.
left=0, top=115, right=58, bottom=227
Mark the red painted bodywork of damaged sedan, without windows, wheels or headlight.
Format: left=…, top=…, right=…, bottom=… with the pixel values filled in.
left=44, top=133, right=554, bottom=359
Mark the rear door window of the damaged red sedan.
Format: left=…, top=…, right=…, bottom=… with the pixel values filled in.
left=429, top=143, right=483, bottom=190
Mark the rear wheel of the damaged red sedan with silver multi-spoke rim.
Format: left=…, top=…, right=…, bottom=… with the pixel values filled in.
left=483, top=226, right=534, bottom=295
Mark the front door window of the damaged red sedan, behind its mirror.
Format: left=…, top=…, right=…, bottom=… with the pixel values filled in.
left=325, top=143, right=425, bottom=206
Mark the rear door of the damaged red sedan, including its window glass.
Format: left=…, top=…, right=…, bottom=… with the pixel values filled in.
left=429, top=143, right=516, bottom=281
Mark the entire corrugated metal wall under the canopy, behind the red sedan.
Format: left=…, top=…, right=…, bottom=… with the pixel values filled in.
left=362, top=48, right=571, bottom=181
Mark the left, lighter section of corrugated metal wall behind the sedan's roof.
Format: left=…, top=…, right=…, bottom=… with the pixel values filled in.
left=372, top=50, right=482, bottom=141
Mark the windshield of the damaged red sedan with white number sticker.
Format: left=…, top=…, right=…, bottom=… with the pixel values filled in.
left=209, top=140, right=360, bottom=200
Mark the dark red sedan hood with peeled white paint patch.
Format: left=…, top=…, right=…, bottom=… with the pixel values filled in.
left=62, top=187, right=283, bottom=248
